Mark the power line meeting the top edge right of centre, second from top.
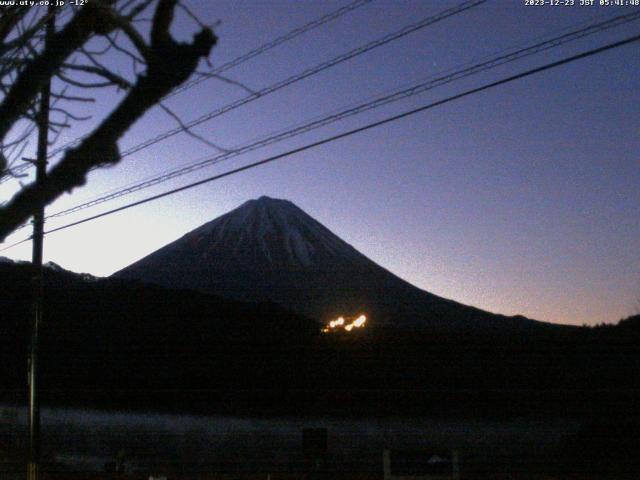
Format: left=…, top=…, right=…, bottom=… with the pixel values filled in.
left=63, top=0, right=488, bottom=158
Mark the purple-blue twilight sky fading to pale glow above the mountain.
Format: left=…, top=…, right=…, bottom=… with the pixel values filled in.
left=0, top=0, right=640, bottom=324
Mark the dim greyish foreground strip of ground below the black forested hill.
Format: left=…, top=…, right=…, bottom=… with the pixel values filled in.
left=0, top=407, right=640, bottom=480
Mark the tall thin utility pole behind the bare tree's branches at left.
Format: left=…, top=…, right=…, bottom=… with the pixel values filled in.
left=27, top=6, right=55, bottom=480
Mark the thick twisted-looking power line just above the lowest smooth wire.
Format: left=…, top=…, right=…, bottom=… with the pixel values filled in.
left=48, top=12, right=640, bottom=218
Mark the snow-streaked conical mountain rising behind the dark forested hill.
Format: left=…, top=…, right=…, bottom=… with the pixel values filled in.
left=114, top=197, right=544, bottom=330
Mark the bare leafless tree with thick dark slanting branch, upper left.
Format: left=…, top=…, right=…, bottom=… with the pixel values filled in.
left=0, top=0, right=217, bottom=241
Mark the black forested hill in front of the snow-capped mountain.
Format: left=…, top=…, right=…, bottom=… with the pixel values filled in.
left=0, top=263, right=640, bottom=415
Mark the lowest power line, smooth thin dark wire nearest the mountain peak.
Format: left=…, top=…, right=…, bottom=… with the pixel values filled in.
left=38, top=31, right=640, bottom=238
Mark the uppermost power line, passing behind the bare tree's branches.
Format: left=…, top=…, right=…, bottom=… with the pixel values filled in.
left=49, top=0, right=373, bottom=157
